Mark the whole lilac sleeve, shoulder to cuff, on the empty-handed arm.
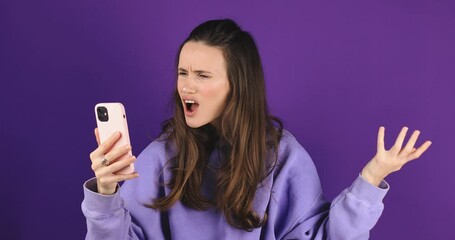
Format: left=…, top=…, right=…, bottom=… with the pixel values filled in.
left=269, top=132, right=389, bottom=240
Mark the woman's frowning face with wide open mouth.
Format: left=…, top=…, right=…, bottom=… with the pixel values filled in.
left=177, top=41, right=229, bottom=128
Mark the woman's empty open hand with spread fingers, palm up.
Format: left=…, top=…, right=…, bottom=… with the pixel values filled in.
left=362, top=127, right=431, bottom=186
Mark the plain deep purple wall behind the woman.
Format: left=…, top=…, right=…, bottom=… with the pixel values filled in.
left=0, top=0, right=455, bottom=239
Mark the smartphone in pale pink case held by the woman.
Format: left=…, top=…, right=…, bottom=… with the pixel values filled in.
left=95, top=103, right=134, bottom=174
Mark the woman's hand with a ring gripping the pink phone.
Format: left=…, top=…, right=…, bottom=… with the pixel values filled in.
left=90, top=128, right=139, bottom=195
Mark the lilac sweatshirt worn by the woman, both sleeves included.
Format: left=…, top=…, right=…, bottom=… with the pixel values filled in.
left=82, top=131, right=389, bottom=240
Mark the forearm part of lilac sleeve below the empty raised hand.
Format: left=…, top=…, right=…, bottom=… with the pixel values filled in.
left=283, top=176, right=388, bottom=240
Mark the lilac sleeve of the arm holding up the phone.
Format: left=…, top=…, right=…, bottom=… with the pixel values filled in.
left=81, top=139, right=170, bottom=240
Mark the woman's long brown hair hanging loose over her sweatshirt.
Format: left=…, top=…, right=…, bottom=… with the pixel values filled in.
left=150, top=19, right=282, bottom=231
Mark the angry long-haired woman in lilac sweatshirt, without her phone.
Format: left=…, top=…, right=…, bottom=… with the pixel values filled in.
left=82, top=20, right=431, bottom=239
